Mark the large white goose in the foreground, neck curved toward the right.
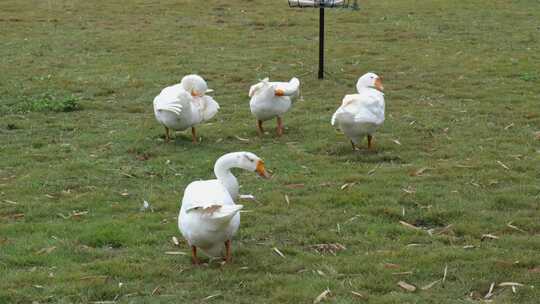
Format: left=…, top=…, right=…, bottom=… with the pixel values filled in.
left=178, top=152, right=269, bottom=264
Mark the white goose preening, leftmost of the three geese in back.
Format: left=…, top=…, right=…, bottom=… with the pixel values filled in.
left=154, top=75, right=219, bottom=143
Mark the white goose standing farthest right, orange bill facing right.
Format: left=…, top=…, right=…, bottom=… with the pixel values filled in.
left=332, top=73, right=384, bottom=150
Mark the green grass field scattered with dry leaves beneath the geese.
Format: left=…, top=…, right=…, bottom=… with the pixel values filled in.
left=0, top=0, right=540, bottom=303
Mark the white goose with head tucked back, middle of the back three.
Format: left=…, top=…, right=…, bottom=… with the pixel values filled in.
left=249, top=77, right=300, bottom=136
